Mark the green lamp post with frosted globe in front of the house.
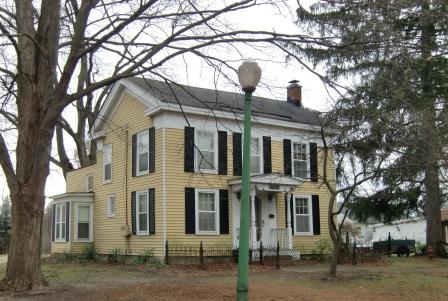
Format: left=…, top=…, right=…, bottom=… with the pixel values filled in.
left=236, top=60, right=261, bottom=301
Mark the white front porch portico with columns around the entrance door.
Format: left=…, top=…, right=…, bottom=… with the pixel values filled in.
left=229, top=173, right=303, bottom=249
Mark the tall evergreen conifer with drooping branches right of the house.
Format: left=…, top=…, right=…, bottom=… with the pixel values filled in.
left=286, top=0, right=448, bottom=253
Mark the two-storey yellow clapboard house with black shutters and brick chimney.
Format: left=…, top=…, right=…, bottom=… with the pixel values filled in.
left=51, top=78, right=334, bottom=257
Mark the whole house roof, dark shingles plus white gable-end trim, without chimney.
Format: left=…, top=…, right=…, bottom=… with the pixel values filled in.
left=91, top=77, right=320, bottom=139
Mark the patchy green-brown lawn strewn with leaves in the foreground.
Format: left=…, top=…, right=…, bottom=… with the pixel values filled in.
left=0, top=257, right=448, bottom=301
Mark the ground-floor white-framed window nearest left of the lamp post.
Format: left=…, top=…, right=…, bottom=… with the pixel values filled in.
left=196, top=190, right=219, bottom=234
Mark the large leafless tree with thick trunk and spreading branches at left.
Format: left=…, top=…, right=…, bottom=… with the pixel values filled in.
left=0, top=0, right=328, bottom=291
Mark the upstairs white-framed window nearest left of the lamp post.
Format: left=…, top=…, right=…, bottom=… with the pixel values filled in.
left=195, top=131, right=217, bottom=171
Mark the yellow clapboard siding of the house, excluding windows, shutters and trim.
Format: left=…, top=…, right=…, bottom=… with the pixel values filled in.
left=57, top=95, right=334, bottom=256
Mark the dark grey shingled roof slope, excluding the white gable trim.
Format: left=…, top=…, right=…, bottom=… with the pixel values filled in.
left=129, top=77, right=320, bottom=126
